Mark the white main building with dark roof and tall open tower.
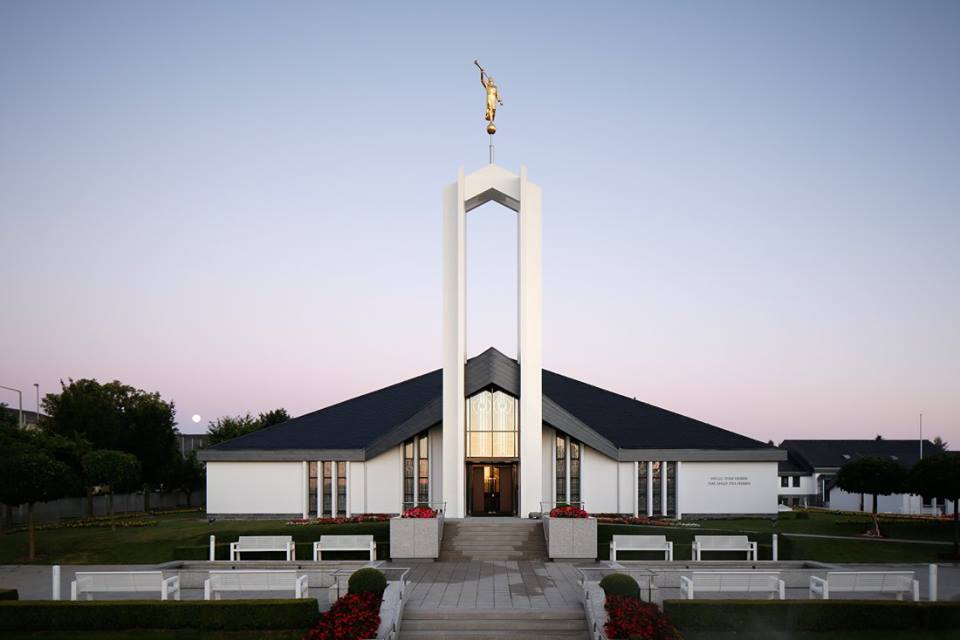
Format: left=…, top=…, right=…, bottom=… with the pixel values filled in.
left=199, top=164, right=786, bottom=518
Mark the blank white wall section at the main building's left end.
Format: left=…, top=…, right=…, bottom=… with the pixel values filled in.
left=207, top=462, right=306, bottom=515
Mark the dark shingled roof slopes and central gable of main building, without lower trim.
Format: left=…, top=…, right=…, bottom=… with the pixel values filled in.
left=206, top=349, right=769, bottom=451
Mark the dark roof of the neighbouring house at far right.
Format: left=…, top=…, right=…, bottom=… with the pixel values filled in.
left=780, top=440, right=939, bottom=469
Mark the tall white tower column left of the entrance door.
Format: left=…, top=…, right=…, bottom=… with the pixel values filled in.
left=440, top=167, right=467, bottom=518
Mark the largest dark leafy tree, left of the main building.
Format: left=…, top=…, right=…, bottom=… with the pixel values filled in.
left=43, top=379, right=177, bottom=509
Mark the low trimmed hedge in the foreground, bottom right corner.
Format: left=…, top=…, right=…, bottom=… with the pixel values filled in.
left=663, top=600, right=960, bottom=632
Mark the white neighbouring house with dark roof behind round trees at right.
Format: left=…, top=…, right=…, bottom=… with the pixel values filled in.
left=777, top=439, right=953, bottom=514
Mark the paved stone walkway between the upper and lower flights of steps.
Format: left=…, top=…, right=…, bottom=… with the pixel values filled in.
left=407, top=560, right=581, bottom=609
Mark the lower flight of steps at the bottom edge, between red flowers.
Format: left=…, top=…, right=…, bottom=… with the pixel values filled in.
left=399, top=608, right=590, bottom=640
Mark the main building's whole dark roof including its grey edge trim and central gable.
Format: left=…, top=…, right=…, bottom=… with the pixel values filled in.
left=201, top=348, right=779, bottom=460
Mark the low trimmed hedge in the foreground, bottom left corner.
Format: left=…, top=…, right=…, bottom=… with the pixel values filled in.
left=0, top=598, right=319, bottom=631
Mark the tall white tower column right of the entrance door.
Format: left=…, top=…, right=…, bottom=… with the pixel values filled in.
left=516, top=167, right=540, bottom=516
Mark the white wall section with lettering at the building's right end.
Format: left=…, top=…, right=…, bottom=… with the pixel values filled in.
left=677, top=462, right=780, bottom=515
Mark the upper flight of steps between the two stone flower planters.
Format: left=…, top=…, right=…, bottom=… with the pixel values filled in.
left=439, top=518, right=547, bottom=562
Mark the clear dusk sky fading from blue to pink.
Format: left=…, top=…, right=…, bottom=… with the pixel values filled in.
left=0, top=1, right=960, bottom=446
